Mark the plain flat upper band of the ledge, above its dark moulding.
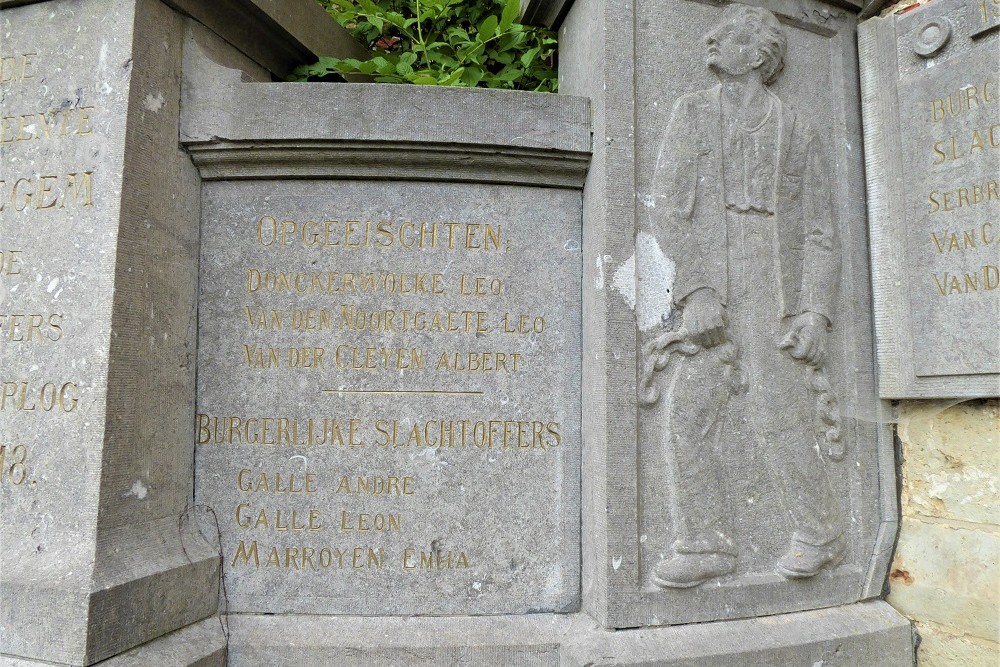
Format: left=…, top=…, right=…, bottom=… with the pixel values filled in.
left=180, top=54, right=591, bottom=153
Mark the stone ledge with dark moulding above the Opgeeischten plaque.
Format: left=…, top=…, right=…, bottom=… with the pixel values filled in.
left=180, top=51, right=591, bottom=189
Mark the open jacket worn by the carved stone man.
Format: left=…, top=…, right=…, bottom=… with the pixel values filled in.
left=651, top=86, right=840, bottom=322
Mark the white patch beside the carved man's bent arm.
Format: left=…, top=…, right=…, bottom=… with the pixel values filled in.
left=612, top=231, right=677, bottom=331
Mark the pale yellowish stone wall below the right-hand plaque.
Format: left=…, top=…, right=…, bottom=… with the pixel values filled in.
left=888, top=400, right=1000, bottom=667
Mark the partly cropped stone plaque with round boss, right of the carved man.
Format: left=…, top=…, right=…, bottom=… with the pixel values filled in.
left=860, top=1, right=1000, bottom=398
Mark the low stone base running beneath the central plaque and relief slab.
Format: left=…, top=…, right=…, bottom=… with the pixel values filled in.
left=219, top=602, right=913, bottom=667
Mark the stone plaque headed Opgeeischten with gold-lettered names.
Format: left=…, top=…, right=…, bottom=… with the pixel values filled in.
left=197, top=181, right=581, bottom=615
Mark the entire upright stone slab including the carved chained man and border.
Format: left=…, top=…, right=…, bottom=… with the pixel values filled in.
left=560, top=1, right=896, bottom=627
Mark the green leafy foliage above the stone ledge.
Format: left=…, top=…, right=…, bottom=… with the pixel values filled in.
left=294, top=0, right=557, bottom=92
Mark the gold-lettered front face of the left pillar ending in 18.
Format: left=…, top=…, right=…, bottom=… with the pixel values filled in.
left=0, top=3, right=121, bottom=660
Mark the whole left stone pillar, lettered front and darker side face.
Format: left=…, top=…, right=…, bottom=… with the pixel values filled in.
left=0, top=0, right=300, bottom=665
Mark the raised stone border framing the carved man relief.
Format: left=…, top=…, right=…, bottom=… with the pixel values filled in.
left=561, top=0, right=897, bottom=628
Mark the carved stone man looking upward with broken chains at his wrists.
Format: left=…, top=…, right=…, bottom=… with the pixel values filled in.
left=639, top=5, right=847, bottom=588
